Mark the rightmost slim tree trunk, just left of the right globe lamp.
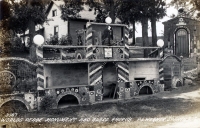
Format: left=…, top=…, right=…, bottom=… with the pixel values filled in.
left=151, top=17, right=157, bottom=46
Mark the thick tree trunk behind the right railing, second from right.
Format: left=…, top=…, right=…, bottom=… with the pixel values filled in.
left=142, top=17, right=149, bottom=57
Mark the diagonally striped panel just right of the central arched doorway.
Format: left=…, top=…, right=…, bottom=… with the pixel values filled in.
left=117, top=62, right=129, bottom=82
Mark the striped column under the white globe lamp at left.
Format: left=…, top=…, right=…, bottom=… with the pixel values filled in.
left=36, top=47, right=44, bottom=90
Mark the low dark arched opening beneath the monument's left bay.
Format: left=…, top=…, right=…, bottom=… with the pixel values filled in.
left=58, top=95, right=79, bottom=108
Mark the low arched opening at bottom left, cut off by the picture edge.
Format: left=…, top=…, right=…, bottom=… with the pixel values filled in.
left=0, top=100, right=28, bottom=115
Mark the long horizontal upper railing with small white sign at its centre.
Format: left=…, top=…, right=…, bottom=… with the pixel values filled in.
left=43, top=45, right=159, bottom=60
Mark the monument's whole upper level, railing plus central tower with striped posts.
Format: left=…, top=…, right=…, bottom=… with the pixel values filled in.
left=37, top=22, right=160, bottom=64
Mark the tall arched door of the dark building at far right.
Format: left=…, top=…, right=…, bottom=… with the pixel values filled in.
left=174, top=28, right=189, bottom=57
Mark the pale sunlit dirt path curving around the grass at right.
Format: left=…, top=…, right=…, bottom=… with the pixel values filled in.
left=102, top=78, right=200, bottom=128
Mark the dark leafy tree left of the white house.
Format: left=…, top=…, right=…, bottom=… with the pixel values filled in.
left=10, top=0, right=46, bottom=46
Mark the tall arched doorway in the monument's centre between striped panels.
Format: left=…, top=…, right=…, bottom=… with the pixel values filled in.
left=103, top=62, right=117, bottom=100
